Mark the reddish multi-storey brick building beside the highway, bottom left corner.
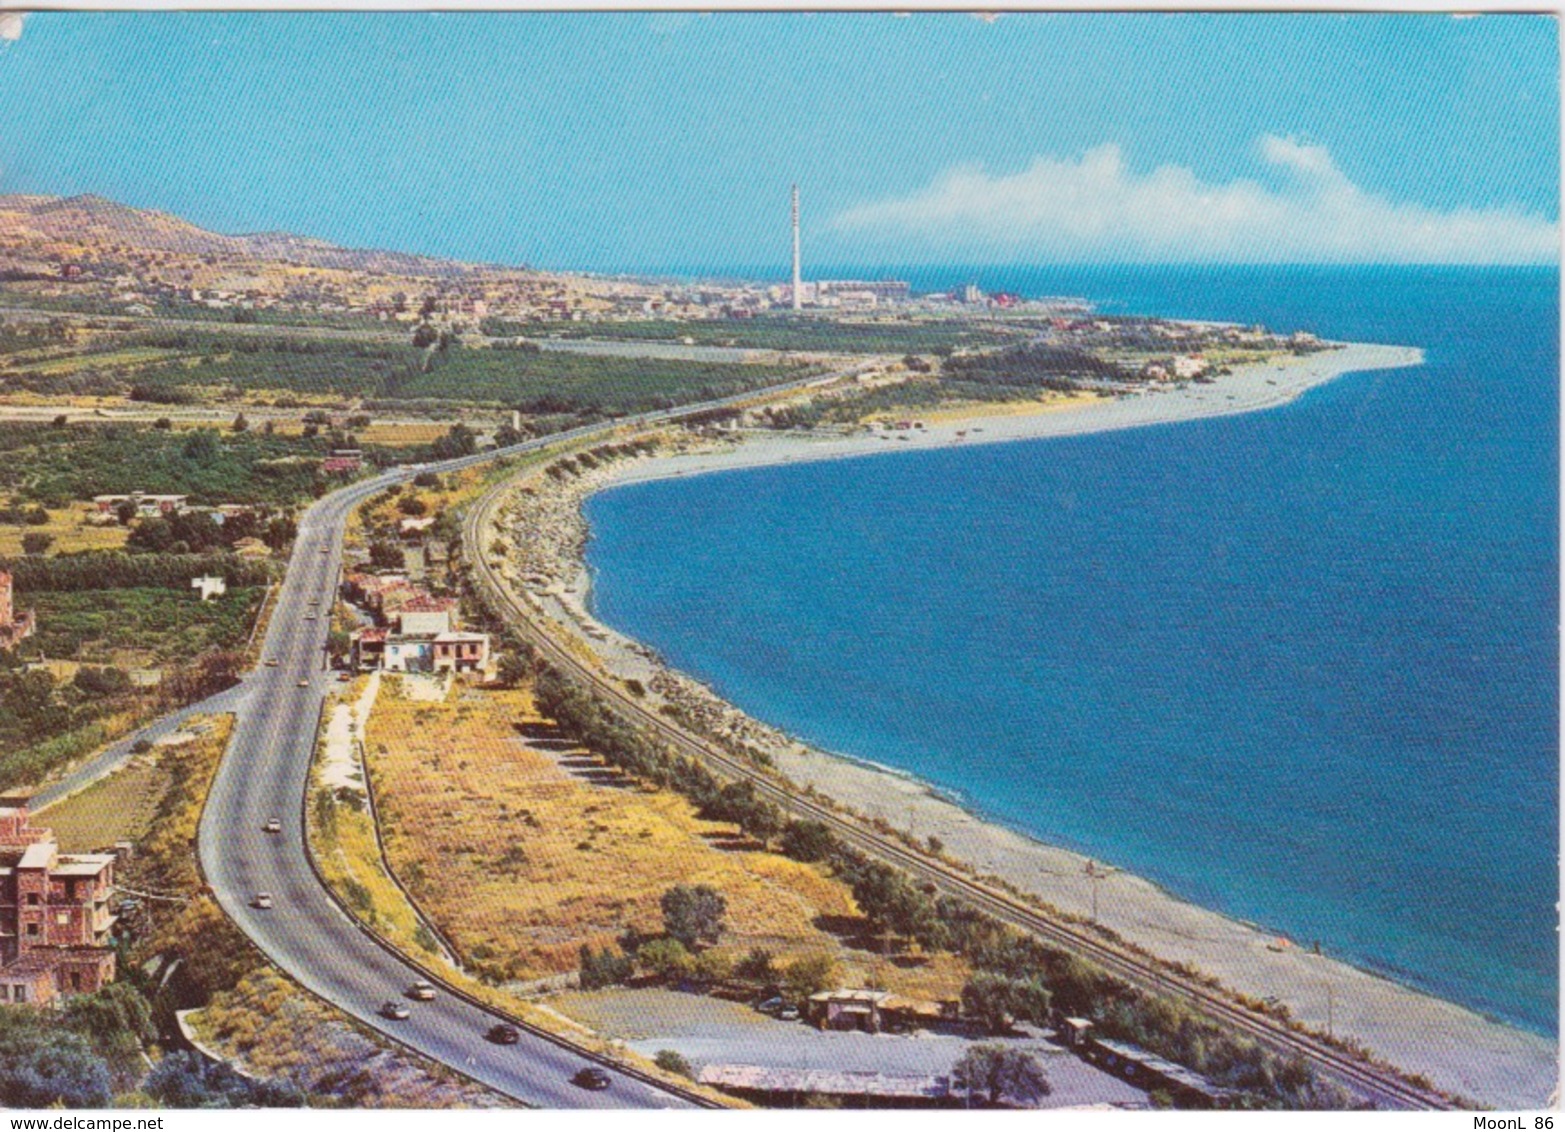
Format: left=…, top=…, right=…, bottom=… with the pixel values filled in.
left=0, top=799, right=114, bottom=1005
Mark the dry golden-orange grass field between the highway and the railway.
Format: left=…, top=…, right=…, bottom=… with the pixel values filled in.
left=366, top=673, right=966, bottom=997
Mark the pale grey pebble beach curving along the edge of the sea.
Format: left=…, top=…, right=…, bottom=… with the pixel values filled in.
left=482, top=344, right=1559, bottom=1109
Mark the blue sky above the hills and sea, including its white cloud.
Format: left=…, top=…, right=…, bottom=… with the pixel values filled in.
left=0, top=13, right=1560, bottom=272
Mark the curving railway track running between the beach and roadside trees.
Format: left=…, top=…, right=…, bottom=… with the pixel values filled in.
left=463, top=454, right=1457, bottom=1110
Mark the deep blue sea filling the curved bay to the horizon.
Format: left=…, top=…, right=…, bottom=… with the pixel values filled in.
left=588, top=268, right=1559, bottom=1033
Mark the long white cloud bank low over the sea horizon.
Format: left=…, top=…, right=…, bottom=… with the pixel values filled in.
left=831, top=135, right=1559, bottom=263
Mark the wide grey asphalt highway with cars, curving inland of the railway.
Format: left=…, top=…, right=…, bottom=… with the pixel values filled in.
left=190, top=374, right=857, bottom=1109
